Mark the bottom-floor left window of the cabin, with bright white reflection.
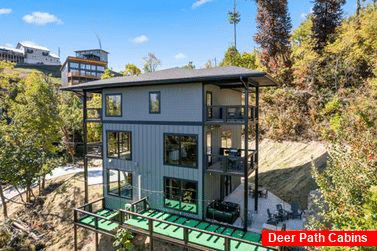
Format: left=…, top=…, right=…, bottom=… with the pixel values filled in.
left=107, top=169, right=132, bottom=200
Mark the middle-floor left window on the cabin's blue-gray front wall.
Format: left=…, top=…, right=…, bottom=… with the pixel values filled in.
left=106, top=131, right=132, bottom=160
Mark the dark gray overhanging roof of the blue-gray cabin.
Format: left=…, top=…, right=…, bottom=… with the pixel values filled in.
left=62, top=66, right=276, bottom=91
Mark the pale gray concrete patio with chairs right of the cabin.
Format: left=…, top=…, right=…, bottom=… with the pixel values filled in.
left=225, top=182, right=304, bottom=233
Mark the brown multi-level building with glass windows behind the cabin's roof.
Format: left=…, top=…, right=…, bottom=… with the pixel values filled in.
left=61, top=49, right=109, bottom=86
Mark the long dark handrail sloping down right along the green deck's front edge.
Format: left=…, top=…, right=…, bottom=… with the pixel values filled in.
left=119, top=209, right=277, bottom=250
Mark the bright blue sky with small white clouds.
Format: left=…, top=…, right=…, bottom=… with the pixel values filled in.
left=0, top=0, right=364, bottom=71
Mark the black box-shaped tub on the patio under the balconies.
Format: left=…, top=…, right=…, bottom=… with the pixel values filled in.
left=207, top=200, right=240, bottom=224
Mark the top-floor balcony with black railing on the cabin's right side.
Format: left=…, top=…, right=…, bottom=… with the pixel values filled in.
left=206, top=105, right=257, bottom=124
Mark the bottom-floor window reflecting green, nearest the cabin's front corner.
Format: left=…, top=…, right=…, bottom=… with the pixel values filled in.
left=164, top=177, right=198, bottom=214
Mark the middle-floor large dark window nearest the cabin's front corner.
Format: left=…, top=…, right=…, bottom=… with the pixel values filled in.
left=164, top=134, right=198, bottom=168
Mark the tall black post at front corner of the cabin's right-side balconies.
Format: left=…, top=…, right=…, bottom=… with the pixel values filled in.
left=241, top=79, right=249, bottom=231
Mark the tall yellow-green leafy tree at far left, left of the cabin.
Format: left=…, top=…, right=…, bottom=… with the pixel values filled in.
left=10, top=72, right=61, bottom=194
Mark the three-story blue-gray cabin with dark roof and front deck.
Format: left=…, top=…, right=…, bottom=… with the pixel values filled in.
left=62, top=67, right=276, bottom=250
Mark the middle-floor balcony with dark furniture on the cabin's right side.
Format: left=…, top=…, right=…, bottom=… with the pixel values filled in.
left=206, top=148, right=256, bottom=176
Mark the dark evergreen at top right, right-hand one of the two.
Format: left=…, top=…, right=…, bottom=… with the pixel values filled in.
left=312, top=0, right=346, bottom=53
